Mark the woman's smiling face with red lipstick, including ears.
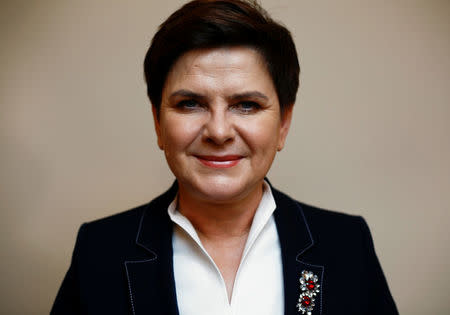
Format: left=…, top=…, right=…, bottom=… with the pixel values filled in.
left=154, top=47, right=292, bottom=202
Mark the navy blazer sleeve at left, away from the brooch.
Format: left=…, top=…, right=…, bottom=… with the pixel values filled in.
left=50, top=224, right=85, bottom=315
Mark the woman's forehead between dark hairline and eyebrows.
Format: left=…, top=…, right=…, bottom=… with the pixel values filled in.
left=163, top=47, right=275, bottom=94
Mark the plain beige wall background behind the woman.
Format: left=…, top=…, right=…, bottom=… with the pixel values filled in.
left=0, top=0, right=450, bottom=314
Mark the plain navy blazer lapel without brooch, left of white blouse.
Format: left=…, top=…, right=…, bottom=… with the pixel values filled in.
left=125, top=183, right=178, bottom=315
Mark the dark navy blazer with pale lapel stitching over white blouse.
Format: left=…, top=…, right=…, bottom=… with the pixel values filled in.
left=50, top=183, right=398, bottom=315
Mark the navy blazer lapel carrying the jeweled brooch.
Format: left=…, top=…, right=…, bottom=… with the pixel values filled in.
left=272, top=188, right=324, bottom=315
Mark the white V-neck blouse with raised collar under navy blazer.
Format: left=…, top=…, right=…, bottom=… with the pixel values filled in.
left=168, top=182, right=284, bottom=315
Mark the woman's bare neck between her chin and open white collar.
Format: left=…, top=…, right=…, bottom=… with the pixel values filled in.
left=178, top=184, right=263, bottom=241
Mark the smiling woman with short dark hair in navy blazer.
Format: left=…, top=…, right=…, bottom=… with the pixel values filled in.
left=52, top=0, right=397, bottom=315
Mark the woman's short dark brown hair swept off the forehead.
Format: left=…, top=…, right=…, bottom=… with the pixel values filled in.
left=144, top=0, right=300, bottom=114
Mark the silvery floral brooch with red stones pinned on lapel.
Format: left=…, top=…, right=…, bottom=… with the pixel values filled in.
left=297, top=270, right=320, bottom=315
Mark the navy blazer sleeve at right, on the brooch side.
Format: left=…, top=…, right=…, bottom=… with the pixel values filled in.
left=360, top=217, right=398, bottom=315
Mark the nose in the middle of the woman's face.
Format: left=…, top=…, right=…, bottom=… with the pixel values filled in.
left=203, top=108, right=235, bottom=145
